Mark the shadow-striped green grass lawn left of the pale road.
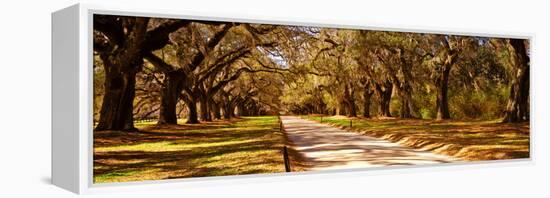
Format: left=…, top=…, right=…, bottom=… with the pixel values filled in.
left=94, top=116, right=285, bottom=183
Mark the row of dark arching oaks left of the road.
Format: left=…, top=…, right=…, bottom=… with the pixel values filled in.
left=94, top=15, right=294, bottom=130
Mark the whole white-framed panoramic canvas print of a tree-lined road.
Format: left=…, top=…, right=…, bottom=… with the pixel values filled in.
left=52, top=5, right=532, bottom=193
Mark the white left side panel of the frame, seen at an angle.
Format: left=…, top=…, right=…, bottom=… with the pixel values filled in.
left=52, top=5, right=82, bottom=192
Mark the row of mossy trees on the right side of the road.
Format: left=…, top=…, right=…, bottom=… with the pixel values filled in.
left=284, top=28, right=529, bottom=122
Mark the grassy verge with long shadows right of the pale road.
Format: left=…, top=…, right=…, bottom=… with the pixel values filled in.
left=302, top=115, right=529, bottom=161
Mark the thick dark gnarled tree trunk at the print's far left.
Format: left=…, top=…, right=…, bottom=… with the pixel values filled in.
left=94, top=17, right=149, bottom=131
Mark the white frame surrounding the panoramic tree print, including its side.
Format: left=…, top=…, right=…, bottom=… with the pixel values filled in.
left=52, top=4, right=535, bottom=194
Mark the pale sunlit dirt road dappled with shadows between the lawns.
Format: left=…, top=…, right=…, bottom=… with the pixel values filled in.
left=281, top=116, right=459, bottom=170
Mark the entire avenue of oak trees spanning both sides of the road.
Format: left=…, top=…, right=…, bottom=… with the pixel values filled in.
left=93, top=15, right=530, bottom=131
